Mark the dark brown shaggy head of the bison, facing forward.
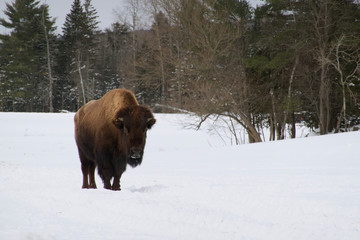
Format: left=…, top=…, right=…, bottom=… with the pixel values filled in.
left=113, top=106, right=156, bottom=167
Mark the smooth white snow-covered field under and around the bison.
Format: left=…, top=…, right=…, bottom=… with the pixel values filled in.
left=0, top=113, right=360, bottom=240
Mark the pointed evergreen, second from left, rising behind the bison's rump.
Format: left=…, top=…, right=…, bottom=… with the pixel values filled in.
left=58, top=0, right=98, bottom=110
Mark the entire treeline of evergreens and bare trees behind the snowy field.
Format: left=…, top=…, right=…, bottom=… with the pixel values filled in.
left=0, top=0, right=360, bottom=142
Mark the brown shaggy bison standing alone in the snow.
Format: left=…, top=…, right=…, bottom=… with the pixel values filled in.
left=74, top=89, right=156, bottom=190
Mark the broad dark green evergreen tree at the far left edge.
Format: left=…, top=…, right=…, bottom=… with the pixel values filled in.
left=0, top=0, right=55, bottom=111
